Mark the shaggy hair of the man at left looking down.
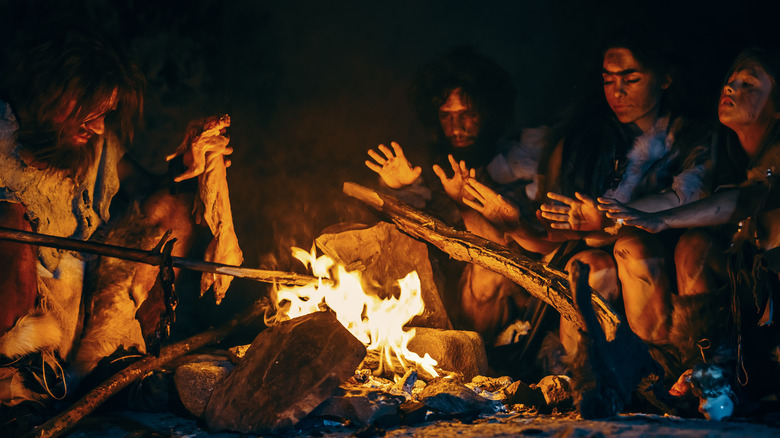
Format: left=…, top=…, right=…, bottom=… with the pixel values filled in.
left=2, top=19, right=145, bottom=178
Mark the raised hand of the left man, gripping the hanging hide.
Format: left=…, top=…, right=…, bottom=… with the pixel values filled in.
left=165, top=114, right=233, bottom=182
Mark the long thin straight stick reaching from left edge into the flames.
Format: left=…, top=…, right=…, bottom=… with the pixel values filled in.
left=0, top=227, right=322, bottom=286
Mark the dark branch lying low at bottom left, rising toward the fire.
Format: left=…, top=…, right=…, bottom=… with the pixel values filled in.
left=24, top=302, right=267, bottom=438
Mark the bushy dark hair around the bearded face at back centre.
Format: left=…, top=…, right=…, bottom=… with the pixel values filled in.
left=410, top=46, right=517, bottom=167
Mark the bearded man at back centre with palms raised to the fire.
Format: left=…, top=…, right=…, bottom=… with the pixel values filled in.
left=366, top=46, right=552, bottom=378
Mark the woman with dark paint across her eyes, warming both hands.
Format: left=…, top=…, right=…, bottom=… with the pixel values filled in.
left=465, top=32, right=711, bottom=366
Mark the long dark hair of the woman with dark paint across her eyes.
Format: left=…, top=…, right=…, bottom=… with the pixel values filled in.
left=539, top=30, right=685, bottom=197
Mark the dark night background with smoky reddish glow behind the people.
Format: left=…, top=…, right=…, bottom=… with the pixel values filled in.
left=0, top=0, right=777, bottom=326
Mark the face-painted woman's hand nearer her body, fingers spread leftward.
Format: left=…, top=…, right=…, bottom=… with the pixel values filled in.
left=540, top=192, right=604, bottom=231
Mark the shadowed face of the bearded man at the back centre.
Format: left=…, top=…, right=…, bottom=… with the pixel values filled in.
left=439, top=88, right=482, bottom=148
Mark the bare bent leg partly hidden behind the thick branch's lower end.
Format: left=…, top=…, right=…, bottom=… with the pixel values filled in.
left=560, top=249, right=620, bottom=355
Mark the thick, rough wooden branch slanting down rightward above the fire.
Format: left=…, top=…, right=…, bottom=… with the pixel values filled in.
left=343, top=182, right=620, bottom=338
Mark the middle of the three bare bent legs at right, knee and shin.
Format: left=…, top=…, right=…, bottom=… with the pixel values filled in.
left=614, top=234, right=671, bottom=344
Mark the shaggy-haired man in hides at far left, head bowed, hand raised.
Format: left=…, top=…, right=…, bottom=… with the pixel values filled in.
left=0, top=17, right=236, bottom=406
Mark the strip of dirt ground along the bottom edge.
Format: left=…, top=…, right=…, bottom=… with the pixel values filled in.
left=68, top=411, right=780, bottom=438
